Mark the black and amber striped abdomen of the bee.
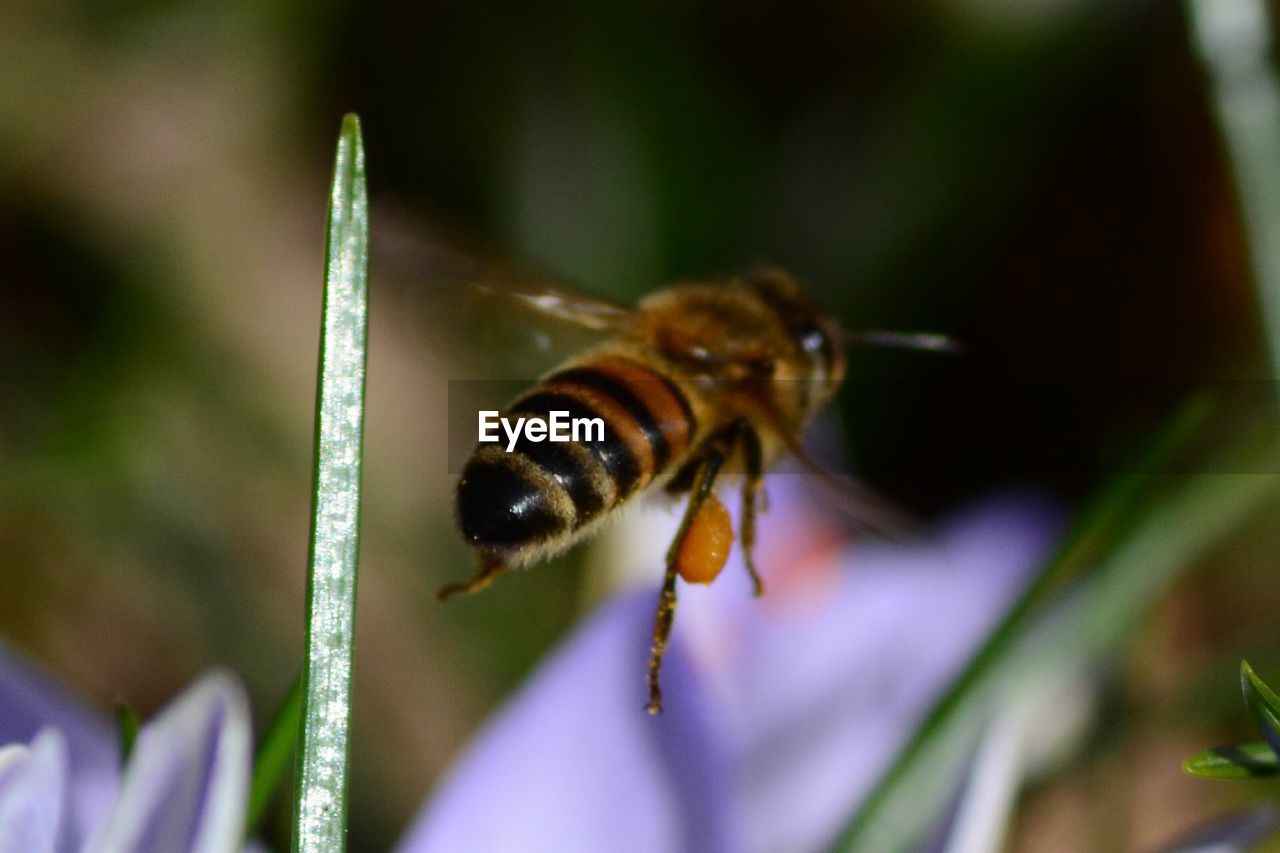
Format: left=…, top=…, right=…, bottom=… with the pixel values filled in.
left=458, top=355, right=696, bottom=562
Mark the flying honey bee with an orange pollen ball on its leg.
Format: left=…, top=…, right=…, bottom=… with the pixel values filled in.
left=438, top=269, right=941, bottom=713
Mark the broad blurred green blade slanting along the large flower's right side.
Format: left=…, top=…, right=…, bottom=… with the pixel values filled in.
left=835, top=409, right=1280, bottom=850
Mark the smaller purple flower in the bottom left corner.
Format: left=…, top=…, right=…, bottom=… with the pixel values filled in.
left=0, top=648, right=251, bottom=853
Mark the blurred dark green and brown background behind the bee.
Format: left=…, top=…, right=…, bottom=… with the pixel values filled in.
left=0, top=0, right=1280, bottom=849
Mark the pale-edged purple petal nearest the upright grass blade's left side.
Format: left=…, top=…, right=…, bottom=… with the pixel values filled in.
left=93, top=674, right=251, bottom=853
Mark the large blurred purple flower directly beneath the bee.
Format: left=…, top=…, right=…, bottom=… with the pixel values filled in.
left=399, top=476, right=1062, bottom=853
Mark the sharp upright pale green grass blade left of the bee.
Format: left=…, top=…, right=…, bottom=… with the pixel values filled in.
left=293, top=115, right=369, bottom=852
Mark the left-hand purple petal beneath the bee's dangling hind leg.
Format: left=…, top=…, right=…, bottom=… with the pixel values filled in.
left=398, top=593, right=737, bottom=853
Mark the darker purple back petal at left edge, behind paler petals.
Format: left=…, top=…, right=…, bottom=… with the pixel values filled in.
left=0, top=644, right=120, bottom=847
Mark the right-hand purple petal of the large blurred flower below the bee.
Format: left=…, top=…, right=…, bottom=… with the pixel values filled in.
left=722, top=489, right=1060, bottom=850
